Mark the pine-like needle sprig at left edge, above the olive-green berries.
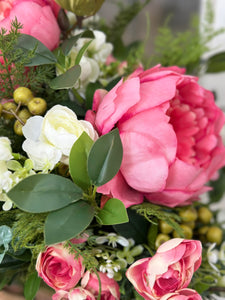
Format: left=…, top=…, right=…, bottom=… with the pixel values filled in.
left=0, top=19, right=54, bottom=99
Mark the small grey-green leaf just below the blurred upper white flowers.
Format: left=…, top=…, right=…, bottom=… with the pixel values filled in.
left=49, top=65, right=81, bottom=90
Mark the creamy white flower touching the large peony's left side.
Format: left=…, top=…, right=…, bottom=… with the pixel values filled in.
left=22, top=105, right=98, bottom=170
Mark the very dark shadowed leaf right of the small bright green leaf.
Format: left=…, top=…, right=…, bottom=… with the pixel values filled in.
left=113, top=209, right=149, bottom=244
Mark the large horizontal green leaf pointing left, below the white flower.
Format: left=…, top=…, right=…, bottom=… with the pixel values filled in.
left=8, top=174, right=82, bottom=213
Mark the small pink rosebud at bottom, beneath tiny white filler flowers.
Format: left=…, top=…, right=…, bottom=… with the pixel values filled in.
left=81, top=271, right=120, bottom=300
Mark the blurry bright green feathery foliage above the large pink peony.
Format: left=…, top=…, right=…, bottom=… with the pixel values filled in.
left=151, top=7, right=223, bottom=73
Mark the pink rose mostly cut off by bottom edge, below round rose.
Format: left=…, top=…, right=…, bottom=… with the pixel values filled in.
left=52, top=287, right=95, bottom=300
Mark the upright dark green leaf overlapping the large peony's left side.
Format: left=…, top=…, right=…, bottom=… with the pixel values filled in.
left=88, top=129, right=123, bottom=186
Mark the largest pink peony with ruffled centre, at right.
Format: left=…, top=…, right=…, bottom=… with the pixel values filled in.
left=86, top=66, right=225, bottom=207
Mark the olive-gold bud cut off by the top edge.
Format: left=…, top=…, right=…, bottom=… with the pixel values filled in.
left=55, top=0, right=104, bottom=16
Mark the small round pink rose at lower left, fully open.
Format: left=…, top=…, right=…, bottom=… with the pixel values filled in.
left=36, top=244, right=84, bottom=291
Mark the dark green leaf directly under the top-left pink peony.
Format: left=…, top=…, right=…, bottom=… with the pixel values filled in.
left=16, top=33, right=57, bottom=67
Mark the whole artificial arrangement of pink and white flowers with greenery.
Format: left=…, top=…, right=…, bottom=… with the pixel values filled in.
left=0, top=0, right=225, bottom=300
